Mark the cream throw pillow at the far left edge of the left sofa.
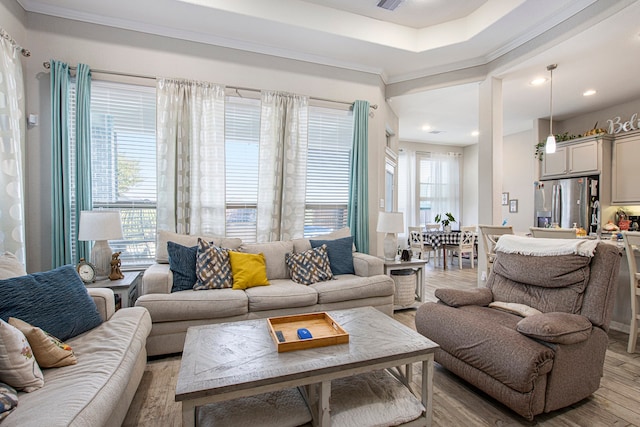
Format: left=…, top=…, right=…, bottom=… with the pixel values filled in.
left=0, top=319, right=44, bottom=392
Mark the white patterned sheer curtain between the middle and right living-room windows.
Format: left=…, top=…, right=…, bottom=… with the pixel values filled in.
left=257, top=92, right=309, bottom=242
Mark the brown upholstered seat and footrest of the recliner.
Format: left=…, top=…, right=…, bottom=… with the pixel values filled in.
left=416, top=302, right=554, bottom=393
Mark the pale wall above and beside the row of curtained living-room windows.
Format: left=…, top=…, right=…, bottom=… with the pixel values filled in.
left=22, top=11, right=389, bottom=271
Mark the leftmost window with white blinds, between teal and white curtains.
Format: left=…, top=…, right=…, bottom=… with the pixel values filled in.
left=70, top=81, right=157, bottom=267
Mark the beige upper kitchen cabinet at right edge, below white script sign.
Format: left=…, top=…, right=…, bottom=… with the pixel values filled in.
left=611, top=132, right=640, bottom=204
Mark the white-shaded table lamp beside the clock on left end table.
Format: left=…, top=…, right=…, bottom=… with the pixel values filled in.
left=78, top=210, right=122, bottom=280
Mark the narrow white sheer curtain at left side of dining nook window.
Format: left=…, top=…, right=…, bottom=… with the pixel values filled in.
left=398, top=150, right=424, bottom=247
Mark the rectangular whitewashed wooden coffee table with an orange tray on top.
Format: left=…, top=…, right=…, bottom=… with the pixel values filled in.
left=175, top=307, right=438, bottom=426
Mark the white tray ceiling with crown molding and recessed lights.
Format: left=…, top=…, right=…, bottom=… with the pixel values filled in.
left=18, top=0, right=640, bottom=146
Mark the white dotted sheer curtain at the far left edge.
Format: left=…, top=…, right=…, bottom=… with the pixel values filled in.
left=0, top=29, right=25, bottom=264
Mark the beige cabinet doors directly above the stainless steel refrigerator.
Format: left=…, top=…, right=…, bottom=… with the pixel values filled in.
left=541, top=135, right=611, bottom=179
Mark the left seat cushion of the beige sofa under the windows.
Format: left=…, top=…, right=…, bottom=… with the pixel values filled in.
left=136, top=289, right=249, bottom=323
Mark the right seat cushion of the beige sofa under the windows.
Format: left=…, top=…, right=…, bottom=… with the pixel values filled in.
left=310, top=274, right=395, bottom=304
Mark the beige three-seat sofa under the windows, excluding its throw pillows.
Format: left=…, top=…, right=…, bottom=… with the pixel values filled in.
left=136, top=229, right=394, bottom=356
